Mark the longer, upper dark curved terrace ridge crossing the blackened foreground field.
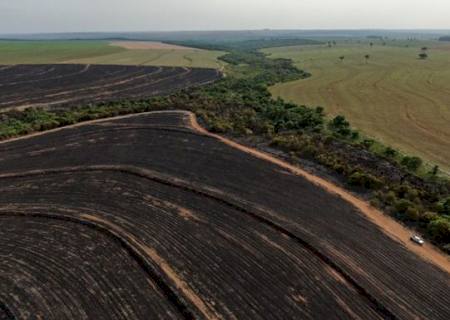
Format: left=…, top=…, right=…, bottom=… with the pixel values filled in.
left=0, top=165, right=397, bottom=319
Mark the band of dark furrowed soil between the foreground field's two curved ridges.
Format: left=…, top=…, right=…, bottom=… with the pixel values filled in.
left=0, top=176, right=380, bottom=319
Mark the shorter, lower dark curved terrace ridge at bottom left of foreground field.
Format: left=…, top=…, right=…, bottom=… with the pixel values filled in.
left=0, top=212, right=198, bottom=319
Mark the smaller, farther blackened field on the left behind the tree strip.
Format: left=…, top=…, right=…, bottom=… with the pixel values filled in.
left=0, top=64, right=220, bottom=112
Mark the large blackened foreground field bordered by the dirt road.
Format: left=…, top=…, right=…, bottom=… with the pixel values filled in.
left=0, top=111, right=450, bottom=319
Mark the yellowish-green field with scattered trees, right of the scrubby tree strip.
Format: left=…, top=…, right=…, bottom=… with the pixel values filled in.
left=264, top=41, right=450, bottom=172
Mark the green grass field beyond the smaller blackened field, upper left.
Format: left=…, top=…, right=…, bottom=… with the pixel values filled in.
left=0, top=41, right=224, bottom=68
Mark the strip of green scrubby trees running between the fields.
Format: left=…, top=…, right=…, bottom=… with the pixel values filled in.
left=0, top=44, right=450, bottom=250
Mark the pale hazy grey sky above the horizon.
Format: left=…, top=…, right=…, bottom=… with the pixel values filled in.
left=0, top=0, right=450, bottom=34
